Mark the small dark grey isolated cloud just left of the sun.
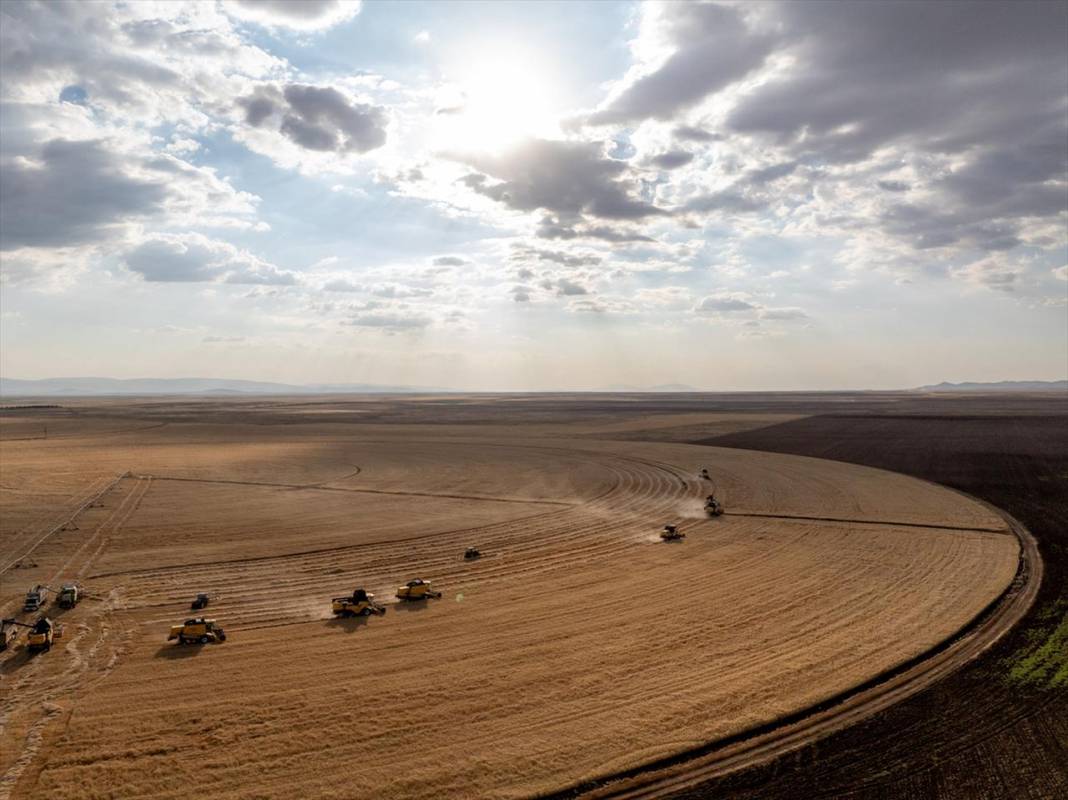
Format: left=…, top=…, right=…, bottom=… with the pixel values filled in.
left=237, top=83, right=389, bottom=153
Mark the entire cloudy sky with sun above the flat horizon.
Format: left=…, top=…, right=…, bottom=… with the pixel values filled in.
left=0, top=0, right=1068, bottom=391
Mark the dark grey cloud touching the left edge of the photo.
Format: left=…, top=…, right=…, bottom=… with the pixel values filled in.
left=0, top=139, right=168, bottom=250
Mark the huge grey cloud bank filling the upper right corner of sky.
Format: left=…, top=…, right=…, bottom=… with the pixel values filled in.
left=589, top=0, right=1068, bottom=276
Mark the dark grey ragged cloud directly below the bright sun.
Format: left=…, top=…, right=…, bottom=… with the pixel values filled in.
left=452, top=139, right=665, bottom=221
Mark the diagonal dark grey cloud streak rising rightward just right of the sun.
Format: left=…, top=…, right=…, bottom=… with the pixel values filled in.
left=588, top=3, right=774, bottom=125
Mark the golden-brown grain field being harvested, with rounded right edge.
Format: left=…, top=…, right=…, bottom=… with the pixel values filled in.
left=0, top=398, right=1033, bottom=798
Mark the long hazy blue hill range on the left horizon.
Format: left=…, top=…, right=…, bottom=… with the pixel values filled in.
left=0, top=378, right=449, bottom=397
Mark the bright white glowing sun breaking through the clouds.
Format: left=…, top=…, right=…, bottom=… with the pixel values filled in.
left=437, top=49, right=559, bottom=152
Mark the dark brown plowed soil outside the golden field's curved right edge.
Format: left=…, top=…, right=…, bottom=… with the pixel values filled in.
left=676, top=408, right=1068, bottom=800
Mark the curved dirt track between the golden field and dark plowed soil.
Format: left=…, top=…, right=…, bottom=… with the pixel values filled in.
left=536, top=493, right=1043, bottom=800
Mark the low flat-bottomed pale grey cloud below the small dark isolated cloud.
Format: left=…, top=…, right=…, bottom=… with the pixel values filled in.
left=124, top=234, right=296, bottom=286
